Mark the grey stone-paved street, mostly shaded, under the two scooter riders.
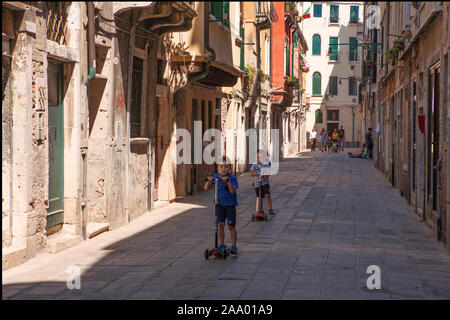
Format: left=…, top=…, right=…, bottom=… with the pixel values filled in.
left=2, top=150, right=450, bottom=300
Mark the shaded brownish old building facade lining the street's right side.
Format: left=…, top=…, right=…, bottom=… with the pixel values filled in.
left=362, top=1, right=450, bottom=252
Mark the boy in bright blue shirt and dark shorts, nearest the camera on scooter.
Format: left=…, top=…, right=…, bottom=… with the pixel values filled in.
left=204, top=158, right=239, bottom=256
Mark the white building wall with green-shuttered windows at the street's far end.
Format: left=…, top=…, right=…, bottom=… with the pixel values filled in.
left=300, top=1, right=363, bottom=148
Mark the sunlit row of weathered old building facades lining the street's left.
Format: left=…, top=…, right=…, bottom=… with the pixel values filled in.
left=2, top=2, right=307, bottom=269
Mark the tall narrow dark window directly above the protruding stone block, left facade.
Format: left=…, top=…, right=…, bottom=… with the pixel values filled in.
left=130, top=57, right=144, bottom=138
